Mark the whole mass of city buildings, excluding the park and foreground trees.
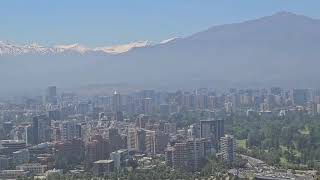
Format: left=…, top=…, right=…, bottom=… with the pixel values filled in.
left=0, top=86, right=320, bottom=176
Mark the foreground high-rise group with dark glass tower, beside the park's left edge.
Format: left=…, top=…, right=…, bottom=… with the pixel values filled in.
left=165, top=118, right=235, bottom=171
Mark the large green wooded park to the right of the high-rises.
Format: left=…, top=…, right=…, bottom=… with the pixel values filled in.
left=226, top=112, right=320, bottom=168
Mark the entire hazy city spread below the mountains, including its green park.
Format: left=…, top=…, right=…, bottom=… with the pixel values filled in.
left=0, top=86, right=320, bottom=180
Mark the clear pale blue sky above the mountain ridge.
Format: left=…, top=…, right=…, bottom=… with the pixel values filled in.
left=0, top=0, right=320, bottom=47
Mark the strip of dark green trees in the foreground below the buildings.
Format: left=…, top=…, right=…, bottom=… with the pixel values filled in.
left=18, top=156, right=228, bottom=180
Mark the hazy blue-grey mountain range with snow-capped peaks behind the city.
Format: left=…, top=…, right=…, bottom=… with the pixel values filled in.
left=0, top=12, right=320, bottom=95
